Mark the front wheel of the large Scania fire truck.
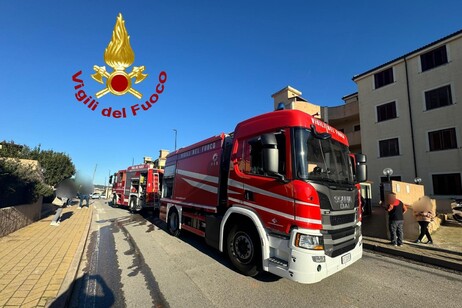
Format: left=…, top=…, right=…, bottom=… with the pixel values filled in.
left=226, top=225, right=261, bottom=277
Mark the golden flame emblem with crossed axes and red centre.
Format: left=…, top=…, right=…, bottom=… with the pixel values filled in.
left=91, top=13, right=148, bottom=99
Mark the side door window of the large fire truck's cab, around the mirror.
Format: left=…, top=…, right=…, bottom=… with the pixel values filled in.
left=239, top=132, right=286, bottom=176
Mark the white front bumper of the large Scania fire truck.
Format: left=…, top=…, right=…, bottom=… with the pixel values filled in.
left=264, top=232, right=363, bottom=283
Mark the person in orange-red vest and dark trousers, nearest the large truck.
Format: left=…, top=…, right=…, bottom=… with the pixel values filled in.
left=384, top=192, right=407, bottom=247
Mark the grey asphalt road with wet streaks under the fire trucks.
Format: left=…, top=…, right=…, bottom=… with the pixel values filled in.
left=71, top=200, right=462, bottom=307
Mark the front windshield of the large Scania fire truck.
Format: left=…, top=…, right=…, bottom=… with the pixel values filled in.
left=294, top=128, right=354, bottom=186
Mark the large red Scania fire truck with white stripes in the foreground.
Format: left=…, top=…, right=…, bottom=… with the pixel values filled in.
left=160, top=110, right=366, bottom=283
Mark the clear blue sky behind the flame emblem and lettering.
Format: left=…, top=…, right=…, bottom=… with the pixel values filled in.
left=0, top=0, right=462, bottom=183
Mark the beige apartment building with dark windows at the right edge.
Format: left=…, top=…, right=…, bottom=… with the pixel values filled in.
left=353, top=31, right=462, bottom=199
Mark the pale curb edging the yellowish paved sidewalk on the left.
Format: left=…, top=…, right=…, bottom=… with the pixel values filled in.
left=46, top=206, right=93, bottom=307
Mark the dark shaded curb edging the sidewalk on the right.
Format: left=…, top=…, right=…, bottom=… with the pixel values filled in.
left=363, top=242, right=462, bottom=272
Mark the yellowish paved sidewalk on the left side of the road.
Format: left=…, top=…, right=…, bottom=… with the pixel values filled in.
left=0, top=205, right=93, bottom=307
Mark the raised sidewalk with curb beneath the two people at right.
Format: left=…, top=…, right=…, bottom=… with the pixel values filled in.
left=363, top=226, right=462, bottom=272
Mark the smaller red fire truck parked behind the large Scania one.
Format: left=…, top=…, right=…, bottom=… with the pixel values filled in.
left=110, top=163, right=164, bottom=212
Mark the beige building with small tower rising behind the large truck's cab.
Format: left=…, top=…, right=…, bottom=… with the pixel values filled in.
left=271, top=86, right=361, bottom=153
